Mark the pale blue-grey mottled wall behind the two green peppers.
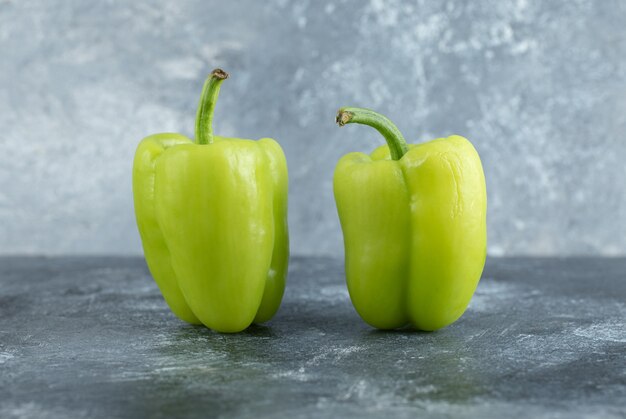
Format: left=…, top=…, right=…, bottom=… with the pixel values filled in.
left=0, top=0, right=626, bottom=255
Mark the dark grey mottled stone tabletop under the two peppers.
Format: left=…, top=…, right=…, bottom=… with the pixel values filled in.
left=0, top=258, right=626, bottom=418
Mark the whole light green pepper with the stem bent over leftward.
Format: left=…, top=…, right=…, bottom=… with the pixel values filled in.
left=334, top=108, right=487, bottom=331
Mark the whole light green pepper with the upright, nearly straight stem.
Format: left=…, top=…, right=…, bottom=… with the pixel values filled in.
left=133, top=70, right=289, bottom=332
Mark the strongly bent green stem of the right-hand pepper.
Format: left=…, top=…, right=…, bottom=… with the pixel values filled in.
left=336, top=107, right=409, bottom=160
